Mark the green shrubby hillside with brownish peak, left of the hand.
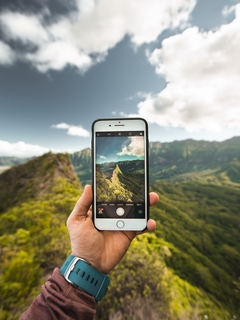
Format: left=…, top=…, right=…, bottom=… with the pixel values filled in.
left=0, top=153, right=81, bottom=320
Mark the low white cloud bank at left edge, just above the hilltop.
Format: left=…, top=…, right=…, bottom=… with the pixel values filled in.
left=0, top=140, right=59, bottom=158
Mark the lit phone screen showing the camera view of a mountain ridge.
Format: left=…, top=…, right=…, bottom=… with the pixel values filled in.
left=95, top=131, right=146, bottom=219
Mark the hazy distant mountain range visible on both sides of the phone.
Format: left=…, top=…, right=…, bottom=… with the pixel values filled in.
left=70, top=137, right=240, bottom=185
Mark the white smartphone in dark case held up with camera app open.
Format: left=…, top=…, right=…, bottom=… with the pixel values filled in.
left=92, top=118, right=149, bottom=231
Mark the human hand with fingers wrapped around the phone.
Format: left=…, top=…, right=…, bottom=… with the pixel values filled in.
left=67, top=185, right=159, bottom=274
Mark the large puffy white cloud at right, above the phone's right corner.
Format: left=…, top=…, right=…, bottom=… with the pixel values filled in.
left=135, top=4, right=240, bottom=131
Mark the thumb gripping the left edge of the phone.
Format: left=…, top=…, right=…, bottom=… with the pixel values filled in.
left=69, top=185, right=92, bottom=219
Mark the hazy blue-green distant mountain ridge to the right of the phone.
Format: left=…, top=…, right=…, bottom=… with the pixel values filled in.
left=149, top=137, right=240, bottom=181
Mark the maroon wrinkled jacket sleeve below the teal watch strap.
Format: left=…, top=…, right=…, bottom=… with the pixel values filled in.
left=20, top=268, right=97, bottom=320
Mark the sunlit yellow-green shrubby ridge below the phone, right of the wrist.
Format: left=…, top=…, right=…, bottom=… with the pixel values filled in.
left=96, top=234, right=231, bottom=320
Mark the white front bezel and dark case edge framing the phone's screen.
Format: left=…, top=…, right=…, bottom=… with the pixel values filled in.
left=92, top=118, right=149, bottom=231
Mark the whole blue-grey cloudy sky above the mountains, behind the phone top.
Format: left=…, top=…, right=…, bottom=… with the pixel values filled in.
left=0, top=0, right=240, bottom=157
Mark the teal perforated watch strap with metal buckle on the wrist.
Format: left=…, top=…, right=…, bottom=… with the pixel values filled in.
left=60, top=254, right=110, bottom=301
